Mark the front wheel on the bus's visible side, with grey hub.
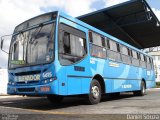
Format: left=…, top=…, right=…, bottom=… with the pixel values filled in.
left=88, top=79, right=102, bottom=105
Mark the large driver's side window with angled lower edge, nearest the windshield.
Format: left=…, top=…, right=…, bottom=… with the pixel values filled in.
left=59, top=31, right=87, bottom=65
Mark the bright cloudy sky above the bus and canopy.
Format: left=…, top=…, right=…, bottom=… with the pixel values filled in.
left=0, top=0, right=160, bottom=68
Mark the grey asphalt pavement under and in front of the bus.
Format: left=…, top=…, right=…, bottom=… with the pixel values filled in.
left=0, top=89, right=160, bottom=120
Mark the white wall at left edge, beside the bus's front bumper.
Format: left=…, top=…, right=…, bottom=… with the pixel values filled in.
left=0, top=69, right=8, bottom=95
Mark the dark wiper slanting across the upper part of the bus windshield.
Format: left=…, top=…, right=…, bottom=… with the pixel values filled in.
left=28, top=23, right=44, bottom=44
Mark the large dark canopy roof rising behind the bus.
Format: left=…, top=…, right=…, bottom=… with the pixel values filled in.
left=77, top=0, right=160, bottom=49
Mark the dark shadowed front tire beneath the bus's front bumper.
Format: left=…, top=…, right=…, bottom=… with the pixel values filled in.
left=47, top=95, right=64, bottom=104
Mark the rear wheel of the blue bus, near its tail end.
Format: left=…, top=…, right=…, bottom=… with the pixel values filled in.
left=133, top=81, right=146, bottom=96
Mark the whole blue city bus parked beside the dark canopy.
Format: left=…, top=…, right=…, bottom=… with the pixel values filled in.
left=1, top=11, right=155, bottom=104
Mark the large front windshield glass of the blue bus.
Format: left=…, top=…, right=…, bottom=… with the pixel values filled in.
left=9, top=23, right=55, bottom=68
